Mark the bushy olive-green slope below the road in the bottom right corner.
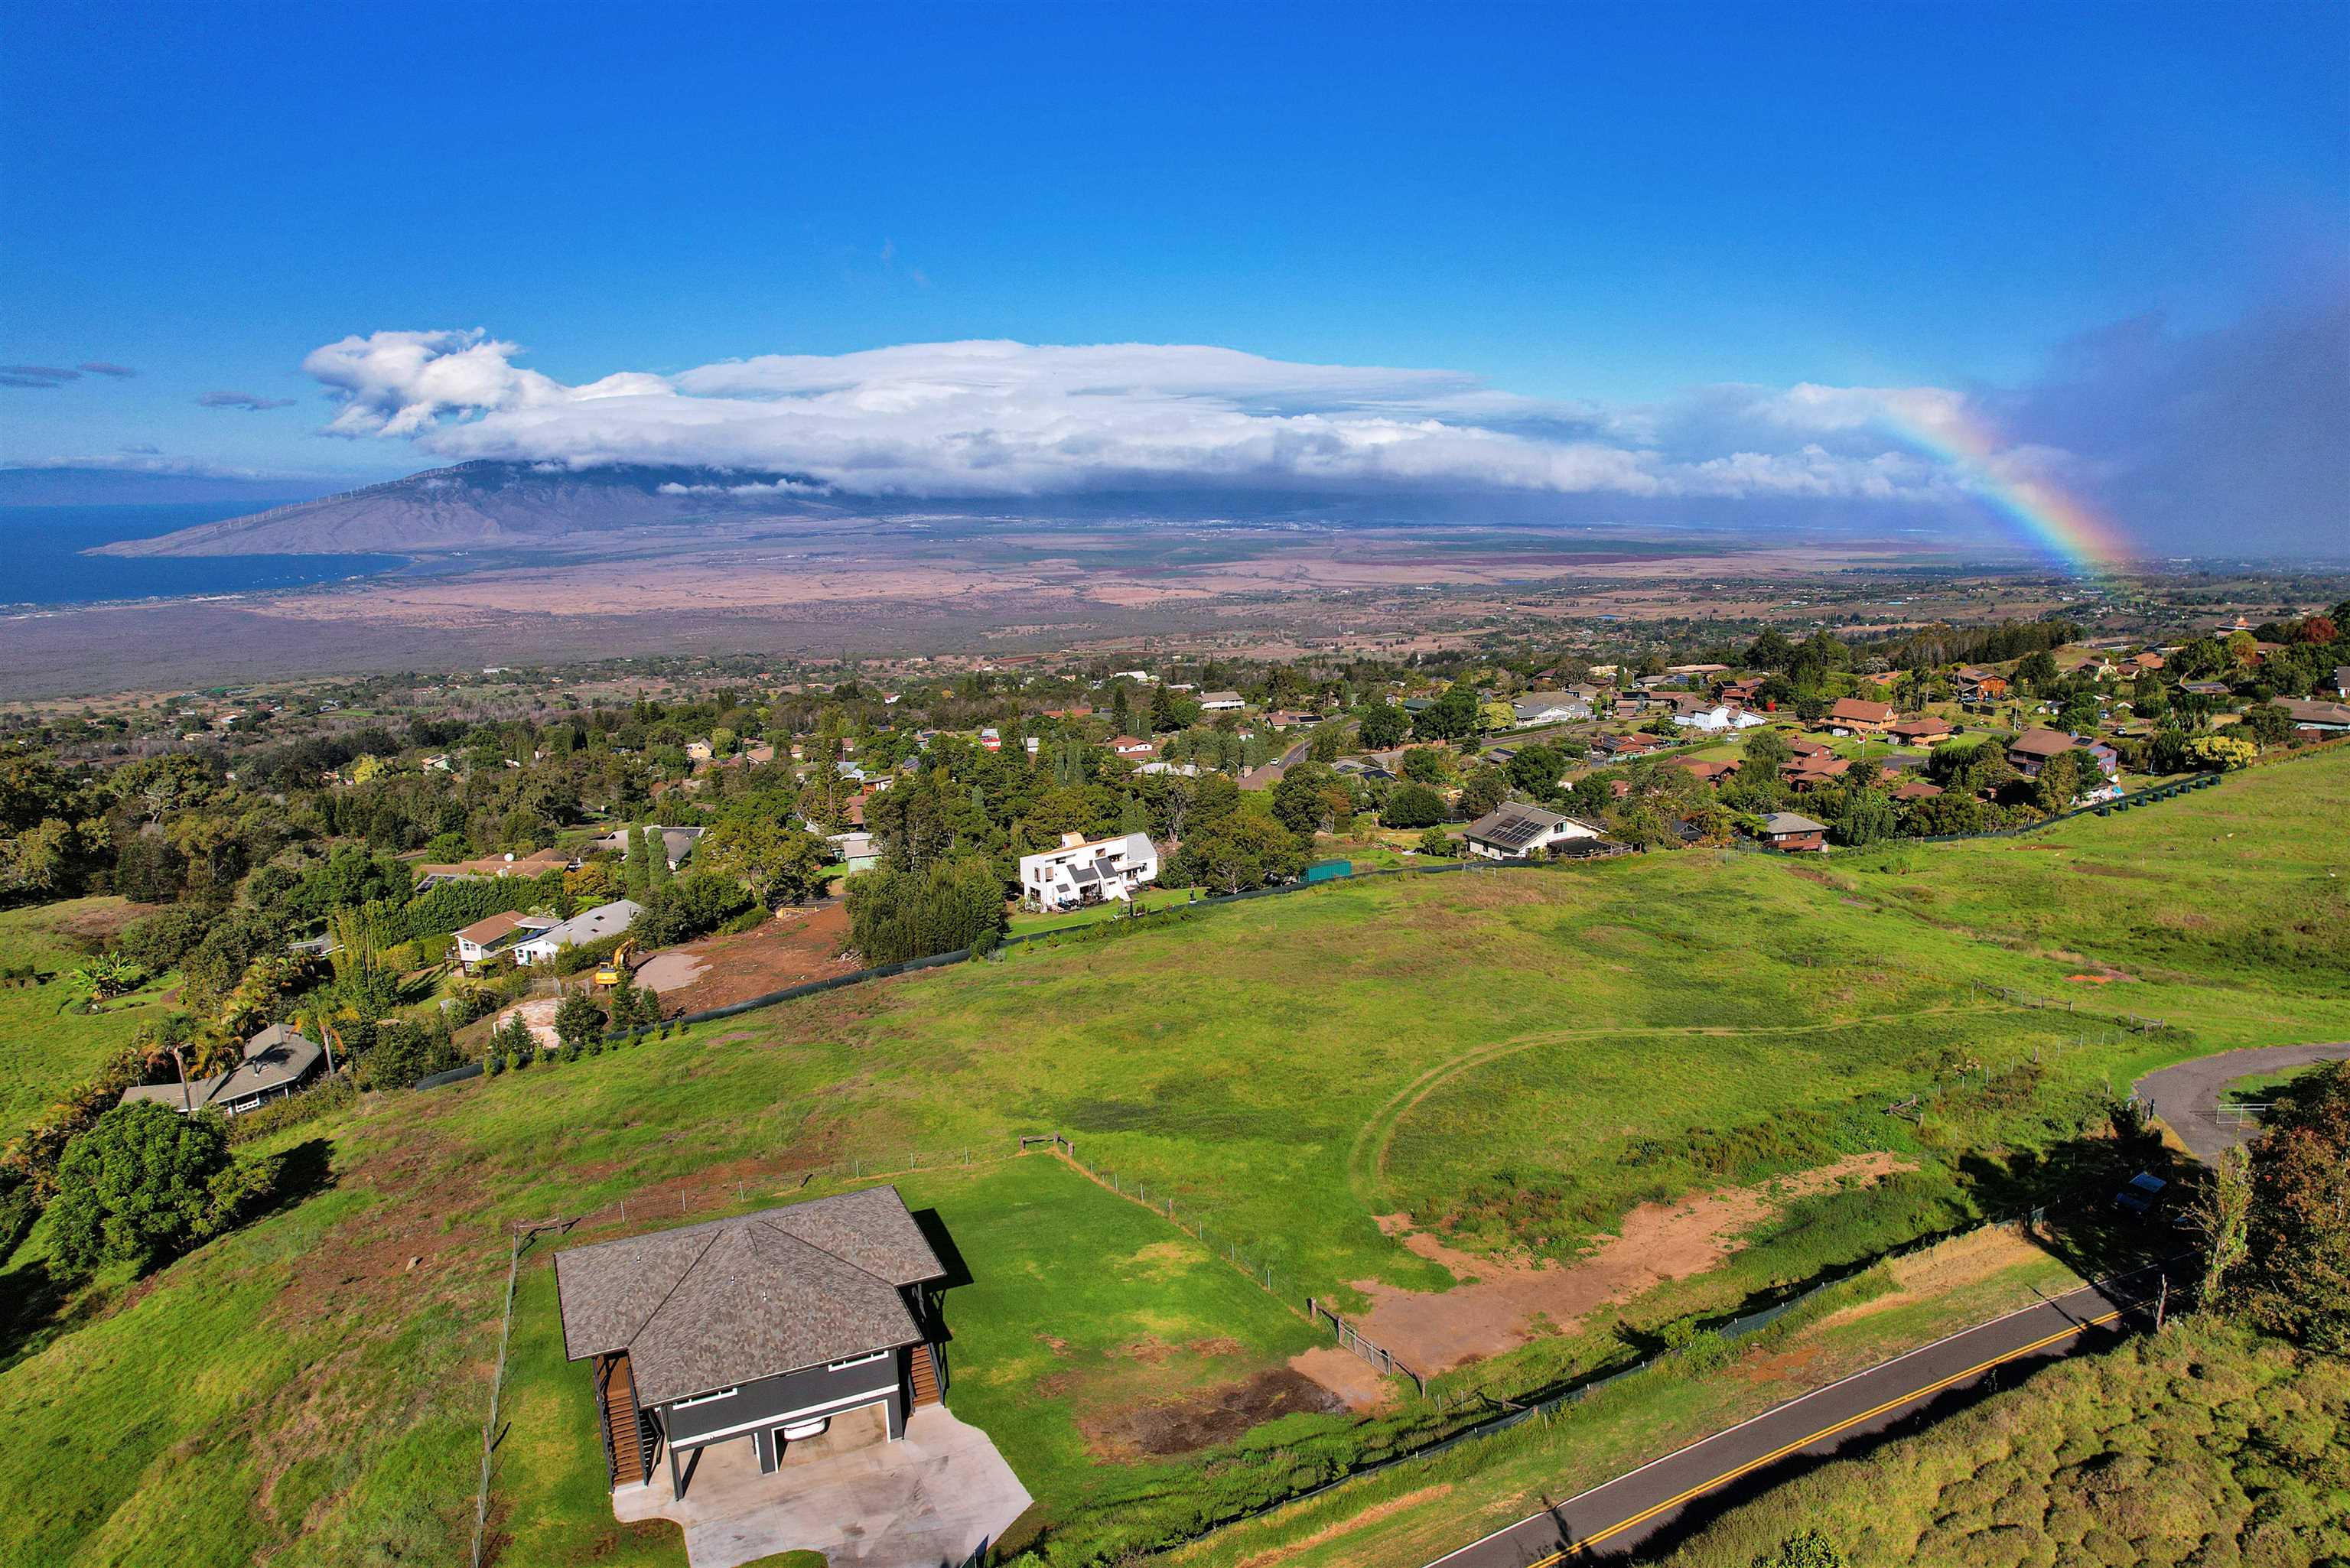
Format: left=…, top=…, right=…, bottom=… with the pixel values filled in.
left=1664, top=1319, right=2350, bottom=1568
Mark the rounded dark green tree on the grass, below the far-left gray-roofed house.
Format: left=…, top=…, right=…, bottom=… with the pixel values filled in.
left=47, top=1100, right=228, bottom=1272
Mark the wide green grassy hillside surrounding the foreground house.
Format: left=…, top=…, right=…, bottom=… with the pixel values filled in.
left=0, top=757, right=2350, bottom=1563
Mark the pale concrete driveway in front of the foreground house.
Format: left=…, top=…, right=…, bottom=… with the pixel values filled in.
left=611, top=1406, right=1030, bottom=1568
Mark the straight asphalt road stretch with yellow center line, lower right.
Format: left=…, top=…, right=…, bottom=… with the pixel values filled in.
left=1431, top=1270, right=2160, bottom=1568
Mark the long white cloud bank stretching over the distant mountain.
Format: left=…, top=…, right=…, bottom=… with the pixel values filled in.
left=303, top=329, right=2030, bottom=499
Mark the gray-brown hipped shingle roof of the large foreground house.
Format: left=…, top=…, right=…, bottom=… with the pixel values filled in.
left=555, top=1187, right=947, bottom=1404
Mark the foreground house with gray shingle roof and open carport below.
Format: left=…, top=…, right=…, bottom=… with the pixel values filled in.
left=555, top=1187, right=947, bottom=1498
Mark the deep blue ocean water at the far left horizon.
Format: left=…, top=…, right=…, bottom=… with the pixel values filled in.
left=0, top=501, right=406, bottom=609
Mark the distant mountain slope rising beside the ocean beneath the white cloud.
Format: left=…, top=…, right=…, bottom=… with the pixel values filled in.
left=92, top=463, right=835, bottom=555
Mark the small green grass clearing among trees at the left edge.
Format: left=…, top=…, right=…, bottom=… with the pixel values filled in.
left=0, top=898, right=174, bottom=1145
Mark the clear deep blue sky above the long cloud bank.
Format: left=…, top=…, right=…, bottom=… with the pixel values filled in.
left=0, top=5, right=2350, bottom=552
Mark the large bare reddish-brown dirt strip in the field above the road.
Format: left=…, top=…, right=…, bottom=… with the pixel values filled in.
left=1356, top=1152, right=1913, bottom=1373
